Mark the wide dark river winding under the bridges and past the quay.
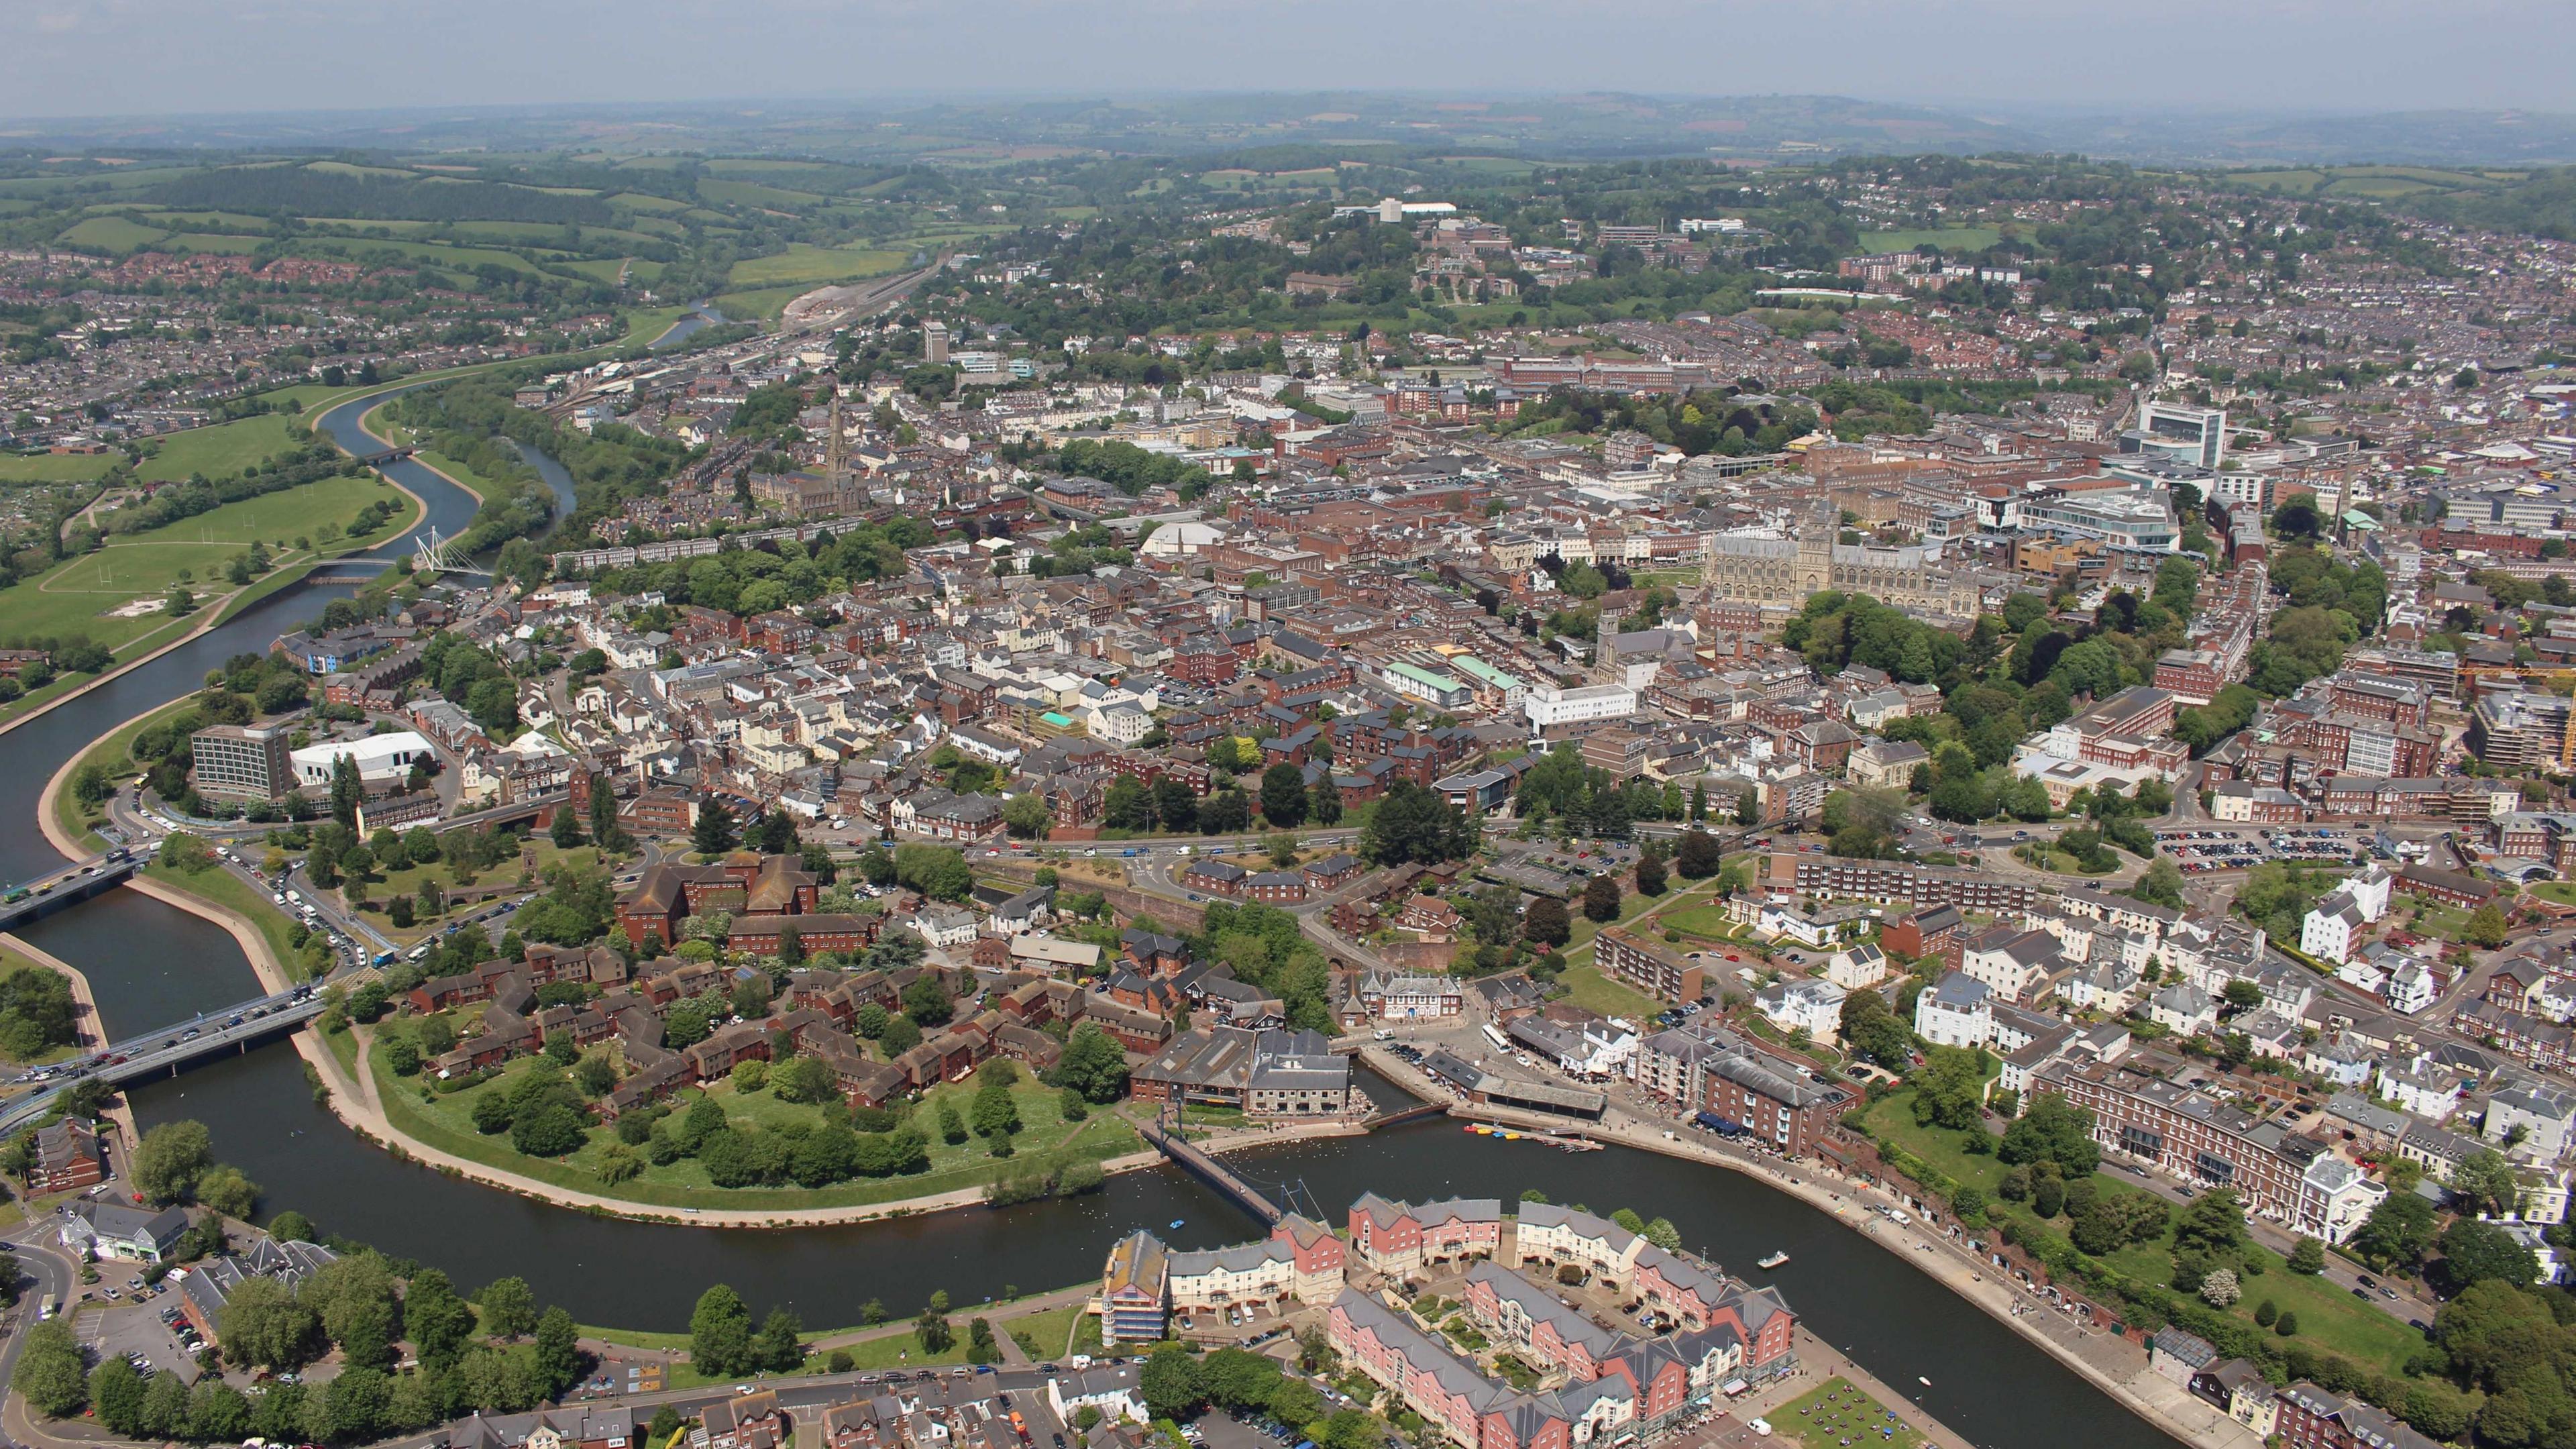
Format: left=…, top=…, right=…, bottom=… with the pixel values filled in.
left=0, top=386, right=2171, bottom=1449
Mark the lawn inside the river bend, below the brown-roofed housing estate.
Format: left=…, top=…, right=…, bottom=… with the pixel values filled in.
left=368, top=1026, right=1141, bottom=1212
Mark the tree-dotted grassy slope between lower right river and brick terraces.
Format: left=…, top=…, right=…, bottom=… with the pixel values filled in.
left=1868, top=1091, right=2424, bottom=1375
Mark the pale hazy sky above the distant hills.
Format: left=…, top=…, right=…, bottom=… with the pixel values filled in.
left=0, top=0, right=2576, bottom=116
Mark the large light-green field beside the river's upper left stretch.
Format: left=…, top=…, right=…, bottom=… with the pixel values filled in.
left=0, top=477, right=420, bottom=655
